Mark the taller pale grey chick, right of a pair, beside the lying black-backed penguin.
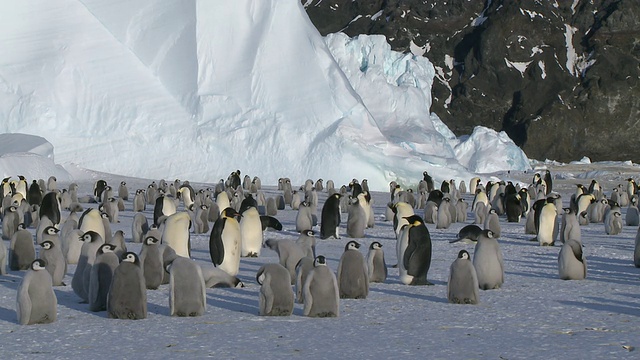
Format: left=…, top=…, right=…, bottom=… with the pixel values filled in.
left=473, top=229, right=504, bottom=290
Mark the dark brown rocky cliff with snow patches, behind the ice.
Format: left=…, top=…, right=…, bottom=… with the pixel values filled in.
left=302, top=0, right=640, bottom=161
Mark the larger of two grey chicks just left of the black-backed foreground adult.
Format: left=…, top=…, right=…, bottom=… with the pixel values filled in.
left=337, top=240, right=369, bottom=299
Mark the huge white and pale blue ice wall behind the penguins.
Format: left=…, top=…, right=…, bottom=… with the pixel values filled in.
left=0, top=0, right=530, bottom=190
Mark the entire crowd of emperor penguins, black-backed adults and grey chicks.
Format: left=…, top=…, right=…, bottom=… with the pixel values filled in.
left=0, top=170, right=640, bottom=324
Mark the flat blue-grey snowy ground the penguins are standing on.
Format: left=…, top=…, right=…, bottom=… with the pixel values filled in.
left=0, top=155, right=640, bottom=359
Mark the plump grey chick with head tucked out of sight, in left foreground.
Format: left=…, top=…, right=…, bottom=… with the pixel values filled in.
left=166, top=256, right=207, bottom=316
